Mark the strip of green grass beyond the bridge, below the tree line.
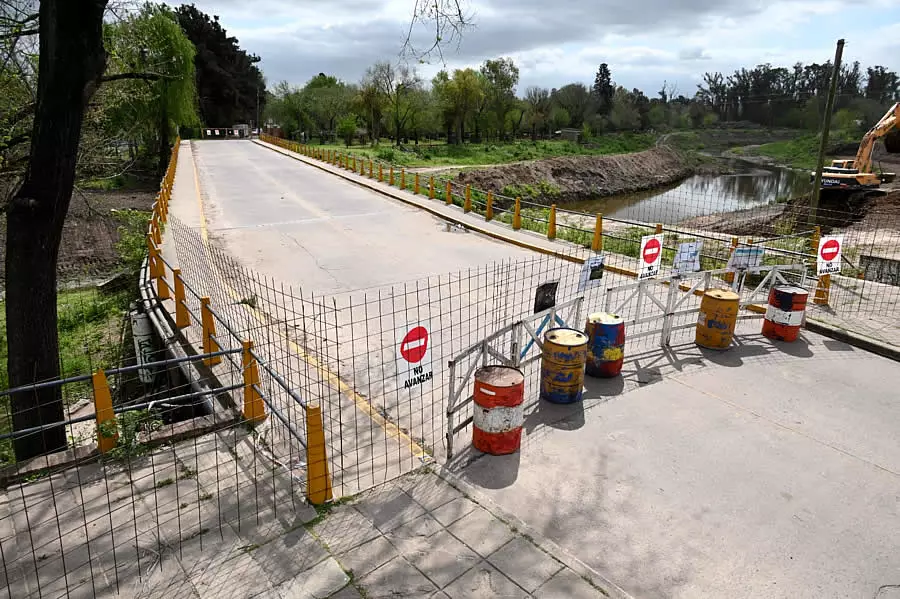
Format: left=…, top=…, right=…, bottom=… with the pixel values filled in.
left=318, top=133, right=656, bottom=167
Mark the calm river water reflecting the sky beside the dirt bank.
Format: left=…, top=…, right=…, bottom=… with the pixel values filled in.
left=565, top=161, right=810, bottom=223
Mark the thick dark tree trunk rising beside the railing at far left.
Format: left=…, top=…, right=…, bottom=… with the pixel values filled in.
left=6, top=0, right=107, bottom=461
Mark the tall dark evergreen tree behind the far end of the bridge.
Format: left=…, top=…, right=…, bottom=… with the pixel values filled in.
left=175, top=4, right=266, bottom=127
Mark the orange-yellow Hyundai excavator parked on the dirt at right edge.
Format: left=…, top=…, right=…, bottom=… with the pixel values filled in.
left=812, top=102, right=900, bottom=195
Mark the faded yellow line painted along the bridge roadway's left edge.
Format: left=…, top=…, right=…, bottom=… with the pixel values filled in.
left=185, top=144, right=432, bottom=462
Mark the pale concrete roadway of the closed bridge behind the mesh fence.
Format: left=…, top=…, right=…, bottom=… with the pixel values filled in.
left=171, top=141, right=556, bottom=495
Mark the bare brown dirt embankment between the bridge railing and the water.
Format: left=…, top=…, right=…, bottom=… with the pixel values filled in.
left=457, top=146, right=709, bottom=205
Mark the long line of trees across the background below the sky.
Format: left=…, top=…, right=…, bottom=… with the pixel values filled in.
left=265, top=58, right=900, bottom=145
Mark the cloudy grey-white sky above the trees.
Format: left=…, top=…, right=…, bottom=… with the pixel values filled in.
left=188, top=0, right=900, bottom=95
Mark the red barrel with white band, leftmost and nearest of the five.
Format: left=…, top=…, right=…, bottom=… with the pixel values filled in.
left=472, top=366, right=525, bottom=455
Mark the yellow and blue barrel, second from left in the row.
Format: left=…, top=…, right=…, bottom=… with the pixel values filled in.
left=541, top=328, right=587, bottom=403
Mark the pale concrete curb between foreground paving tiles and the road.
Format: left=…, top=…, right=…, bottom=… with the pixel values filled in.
left=429, top=462, right=635, bottom=599
